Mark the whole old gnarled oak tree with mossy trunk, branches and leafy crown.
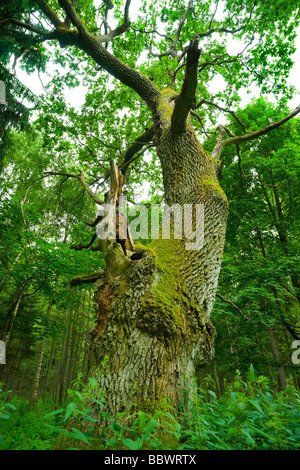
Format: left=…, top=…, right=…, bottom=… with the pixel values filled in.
left=0, top=0, right=300, bottom=426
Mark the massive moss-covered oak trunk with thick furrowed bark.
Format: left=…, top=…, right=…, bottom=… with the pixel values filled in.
left=90, top=82, right=228, bottom=420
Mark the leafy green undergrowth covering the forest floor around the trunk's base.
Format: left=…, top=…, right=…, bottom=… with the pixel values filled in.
left=0, top=366, right=300, bottom=450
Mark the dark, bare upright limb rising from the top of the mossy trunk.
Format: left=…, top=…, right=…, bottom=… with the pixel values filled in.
left=171, top=37, right=201, bottom=135
